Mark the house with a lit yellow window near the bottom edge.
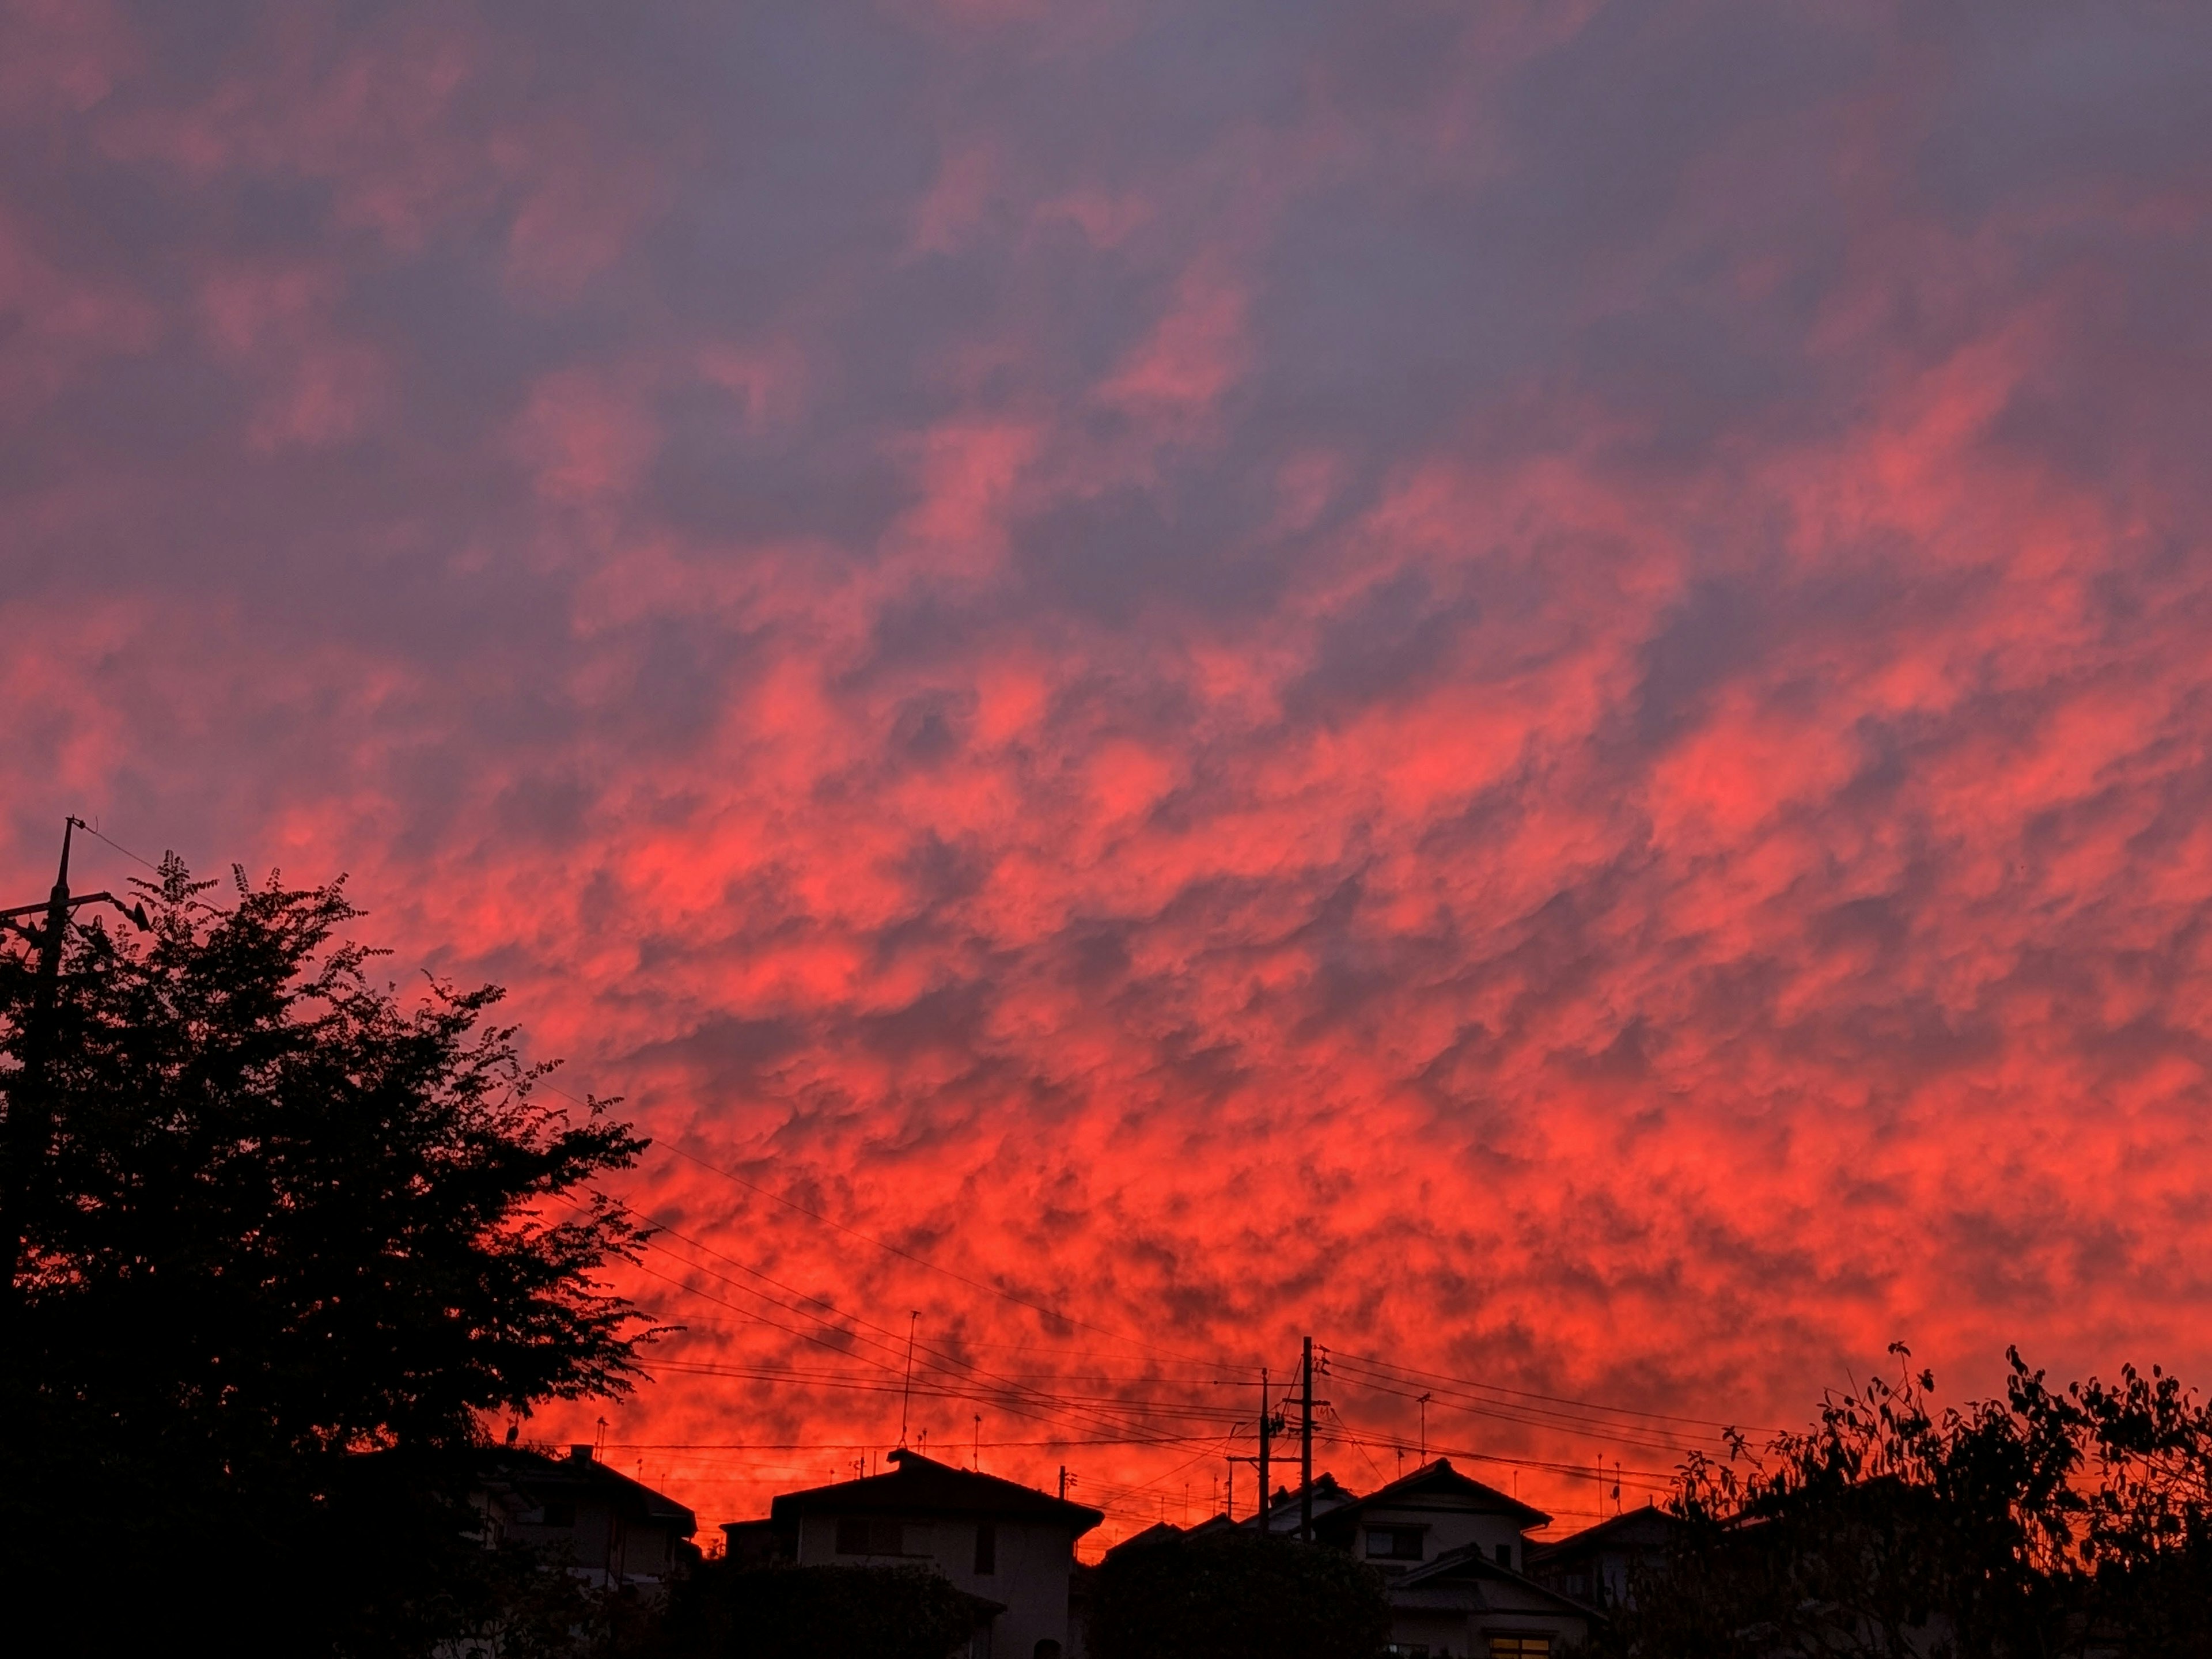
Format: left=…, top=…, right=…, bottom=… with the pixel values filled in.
left=1314, top=1458, right=1593, bottom=1659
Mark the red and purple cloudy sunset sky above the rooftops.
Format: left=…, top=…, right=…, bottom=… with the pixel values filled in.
left=0, top=0, right=2212, bottom=1546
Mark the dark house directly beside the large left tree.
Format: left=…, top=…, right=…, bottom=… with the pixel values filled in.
left=478, top=1446, right=699, bottom=1593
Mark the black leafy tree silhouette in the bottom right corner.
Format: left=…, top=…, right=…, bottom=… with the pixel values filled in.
left=1595, top=1345, right=2212, bottom=1659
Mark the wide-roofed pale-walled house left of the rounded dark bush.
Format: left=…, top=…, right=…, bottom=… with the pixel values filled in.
left=767, top=1451, right=1106, bottom=1659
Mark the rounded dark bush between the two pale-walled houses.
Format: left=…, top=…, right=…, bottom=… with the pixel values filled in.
left=1090, top=1533, right=1389, bottom=1659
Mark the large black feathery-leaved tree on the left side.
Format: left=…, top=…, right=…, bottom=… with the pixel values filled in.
left=0, top=861, right=643, bottom=1652
